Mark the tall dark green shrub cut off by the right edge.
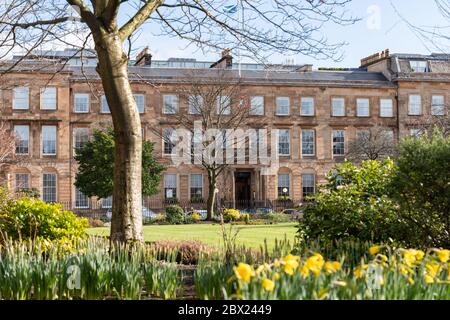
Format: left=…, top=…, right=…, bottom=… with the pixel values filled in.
left=389, top=130, right=450, bottom=248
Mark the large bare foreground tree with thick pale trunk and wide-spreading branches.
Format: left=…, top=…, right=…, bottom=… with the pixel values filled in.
left=0, top=0, right=357, bottom=242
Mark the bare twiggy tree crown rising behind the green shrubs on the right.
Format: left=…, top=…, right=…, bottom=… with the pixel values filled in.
left=346, top=124, right=395, bottom=161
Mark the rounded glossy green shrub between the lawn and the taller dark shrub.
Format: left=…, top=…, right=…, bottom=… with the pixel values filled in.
left=299, top=159, right=402, bottom=242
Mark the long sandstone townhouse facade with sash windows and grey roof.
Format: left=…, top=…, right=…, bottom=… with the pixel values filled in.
left=0, top=50, right=450, bottom=209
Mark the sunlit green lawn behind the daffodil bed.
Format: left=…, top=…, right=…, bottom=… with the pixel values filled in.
left=88, top=223, right=297, bottom=248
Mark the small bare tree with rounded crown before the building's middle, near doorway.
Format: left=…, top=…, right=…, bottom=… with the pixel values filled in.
left=155, top=69, right=263, bottom=219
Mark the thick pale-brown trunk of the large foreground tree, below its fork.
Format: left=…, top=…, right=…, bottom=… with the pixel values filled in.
left=94, top=33, right=143, bottom=243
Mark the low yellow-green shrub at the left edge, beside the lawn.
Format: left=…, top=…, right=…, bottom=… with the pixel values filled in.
left=0, top=198, right=88, bottom=240
